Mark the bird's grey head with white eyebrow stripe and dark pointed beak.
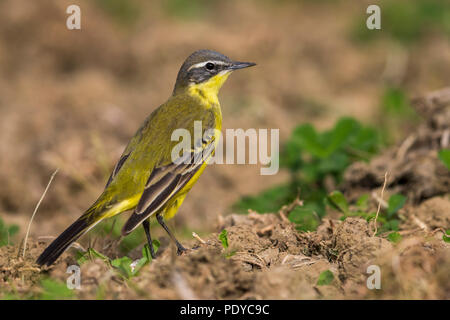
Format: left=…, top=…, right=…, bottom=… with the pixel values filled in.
left=174, top=50, right=255, bottom=93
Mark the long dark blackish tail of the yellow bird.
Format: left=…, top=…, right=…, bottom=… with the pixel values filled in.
left=36, top=215, right=95, bottom=266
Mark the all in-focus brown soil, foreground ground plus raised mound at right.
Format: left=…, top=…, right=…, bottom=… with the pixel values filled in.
left=0, top=90, right=450, bottom=299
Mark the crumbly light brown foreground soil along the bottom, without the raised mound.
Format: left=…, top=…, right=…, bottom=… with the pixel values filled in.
left=0, top=205, right=450, bottom=299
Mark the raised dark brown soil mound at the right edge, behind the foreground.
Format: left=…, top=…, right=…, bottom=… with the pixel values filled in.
left=344, top=89, right=450, bottom=203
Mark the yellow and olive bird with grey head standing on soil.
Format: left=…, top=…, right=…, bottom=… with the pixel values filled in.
left=36, top=49, right=256, bottom=266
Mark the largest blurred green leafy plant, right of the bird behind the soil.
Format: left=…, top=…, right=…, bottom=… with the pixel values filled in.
left=234, top=118, right=380, bottom=231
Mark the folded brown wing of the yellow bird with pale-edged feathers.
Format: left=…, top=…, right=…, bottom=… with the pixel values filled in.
left=122, top=136, right=215, bottom=235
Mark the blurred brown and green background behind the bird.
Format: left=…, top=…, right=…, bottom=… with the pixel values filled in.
left=0, top=0, right=450, bottom=248
